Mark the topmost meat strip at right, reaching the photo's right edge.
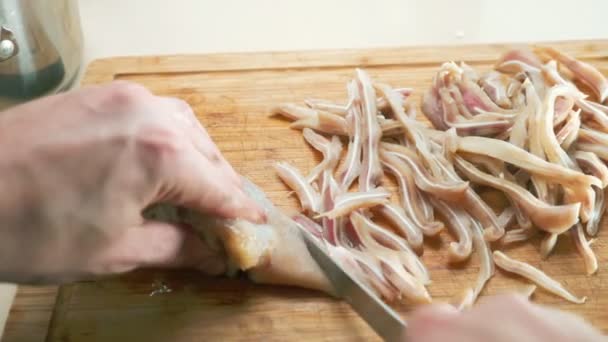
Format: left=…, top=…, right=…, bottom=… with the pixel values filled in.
left=536, top=47, right=608, bottom=102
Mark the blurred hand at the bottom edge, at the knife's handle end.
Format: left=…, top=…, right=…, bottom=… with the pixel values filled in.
left=408, top=295, right=606, bottom=342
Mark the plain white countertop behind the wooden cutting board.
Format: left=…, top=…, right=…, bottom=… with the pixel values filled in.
left=0, top=0, right=608, bottom=336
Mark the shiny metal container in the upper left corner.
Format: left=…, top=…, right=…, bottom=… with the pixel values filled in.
left=0, top=0, right=83, bottom=110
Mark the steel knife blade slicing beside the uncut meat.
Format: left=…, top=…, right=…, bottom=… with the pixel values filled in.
left=302, top=232, right=406, bottom=341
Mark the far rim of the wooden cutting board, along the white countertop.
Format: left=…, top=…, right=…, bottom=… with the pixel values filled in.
left=82, top=39, right=608, bottom=85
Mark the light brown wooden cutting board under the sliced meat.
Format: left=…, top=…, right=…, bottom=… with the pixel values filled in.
left=5, top=41, right=608, bottom=341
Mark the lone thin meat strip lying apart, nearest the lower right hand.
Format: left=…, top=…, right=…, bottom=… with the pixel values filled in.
left=493, top=251, right=587, bottom=304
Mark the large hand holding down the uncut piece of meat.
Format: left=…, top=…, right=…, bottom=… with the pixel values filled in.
left=0, top=82, right=264, bottom=283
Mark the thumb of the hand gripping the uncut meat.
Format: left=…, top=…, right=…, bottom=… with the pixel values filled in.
left=91, top=221, right=226, bottom=275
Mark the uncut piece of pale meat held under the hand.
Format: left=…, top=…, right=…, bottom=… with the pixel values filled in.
left=144, top=180, right=332, bottom=294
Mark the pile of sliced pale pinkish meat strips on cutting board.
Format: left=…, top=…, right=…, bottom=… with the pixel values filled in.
left=273, top=47, right=608, bottom=307
